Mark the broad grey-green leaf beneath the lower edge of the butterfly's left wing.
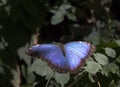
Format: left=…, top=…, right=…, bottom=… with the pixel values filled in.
left=29, top=59, right=53, bottom=76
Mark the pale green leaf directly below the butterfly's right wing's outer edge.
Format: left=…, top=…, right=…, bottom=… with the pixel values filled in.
left=84, top=61, right=102, bottom=74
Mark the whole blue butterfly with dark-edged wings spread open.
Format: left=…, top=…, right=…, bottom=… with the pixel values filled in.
left=27, top=41, right=95, bottom=73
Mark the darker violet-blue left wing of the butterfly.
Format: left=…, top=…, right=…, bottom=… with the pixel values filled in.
left=28, top=44, right=67, bottom=71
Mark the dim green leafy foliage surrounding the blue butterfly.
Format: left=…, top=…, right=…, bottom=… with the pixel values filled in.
left=0, top=0, right=120, bottom=87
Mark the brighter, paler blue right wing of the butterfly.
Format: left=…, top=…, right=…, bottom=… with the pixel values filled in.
left=64, top=41, right=94, bottom=72
